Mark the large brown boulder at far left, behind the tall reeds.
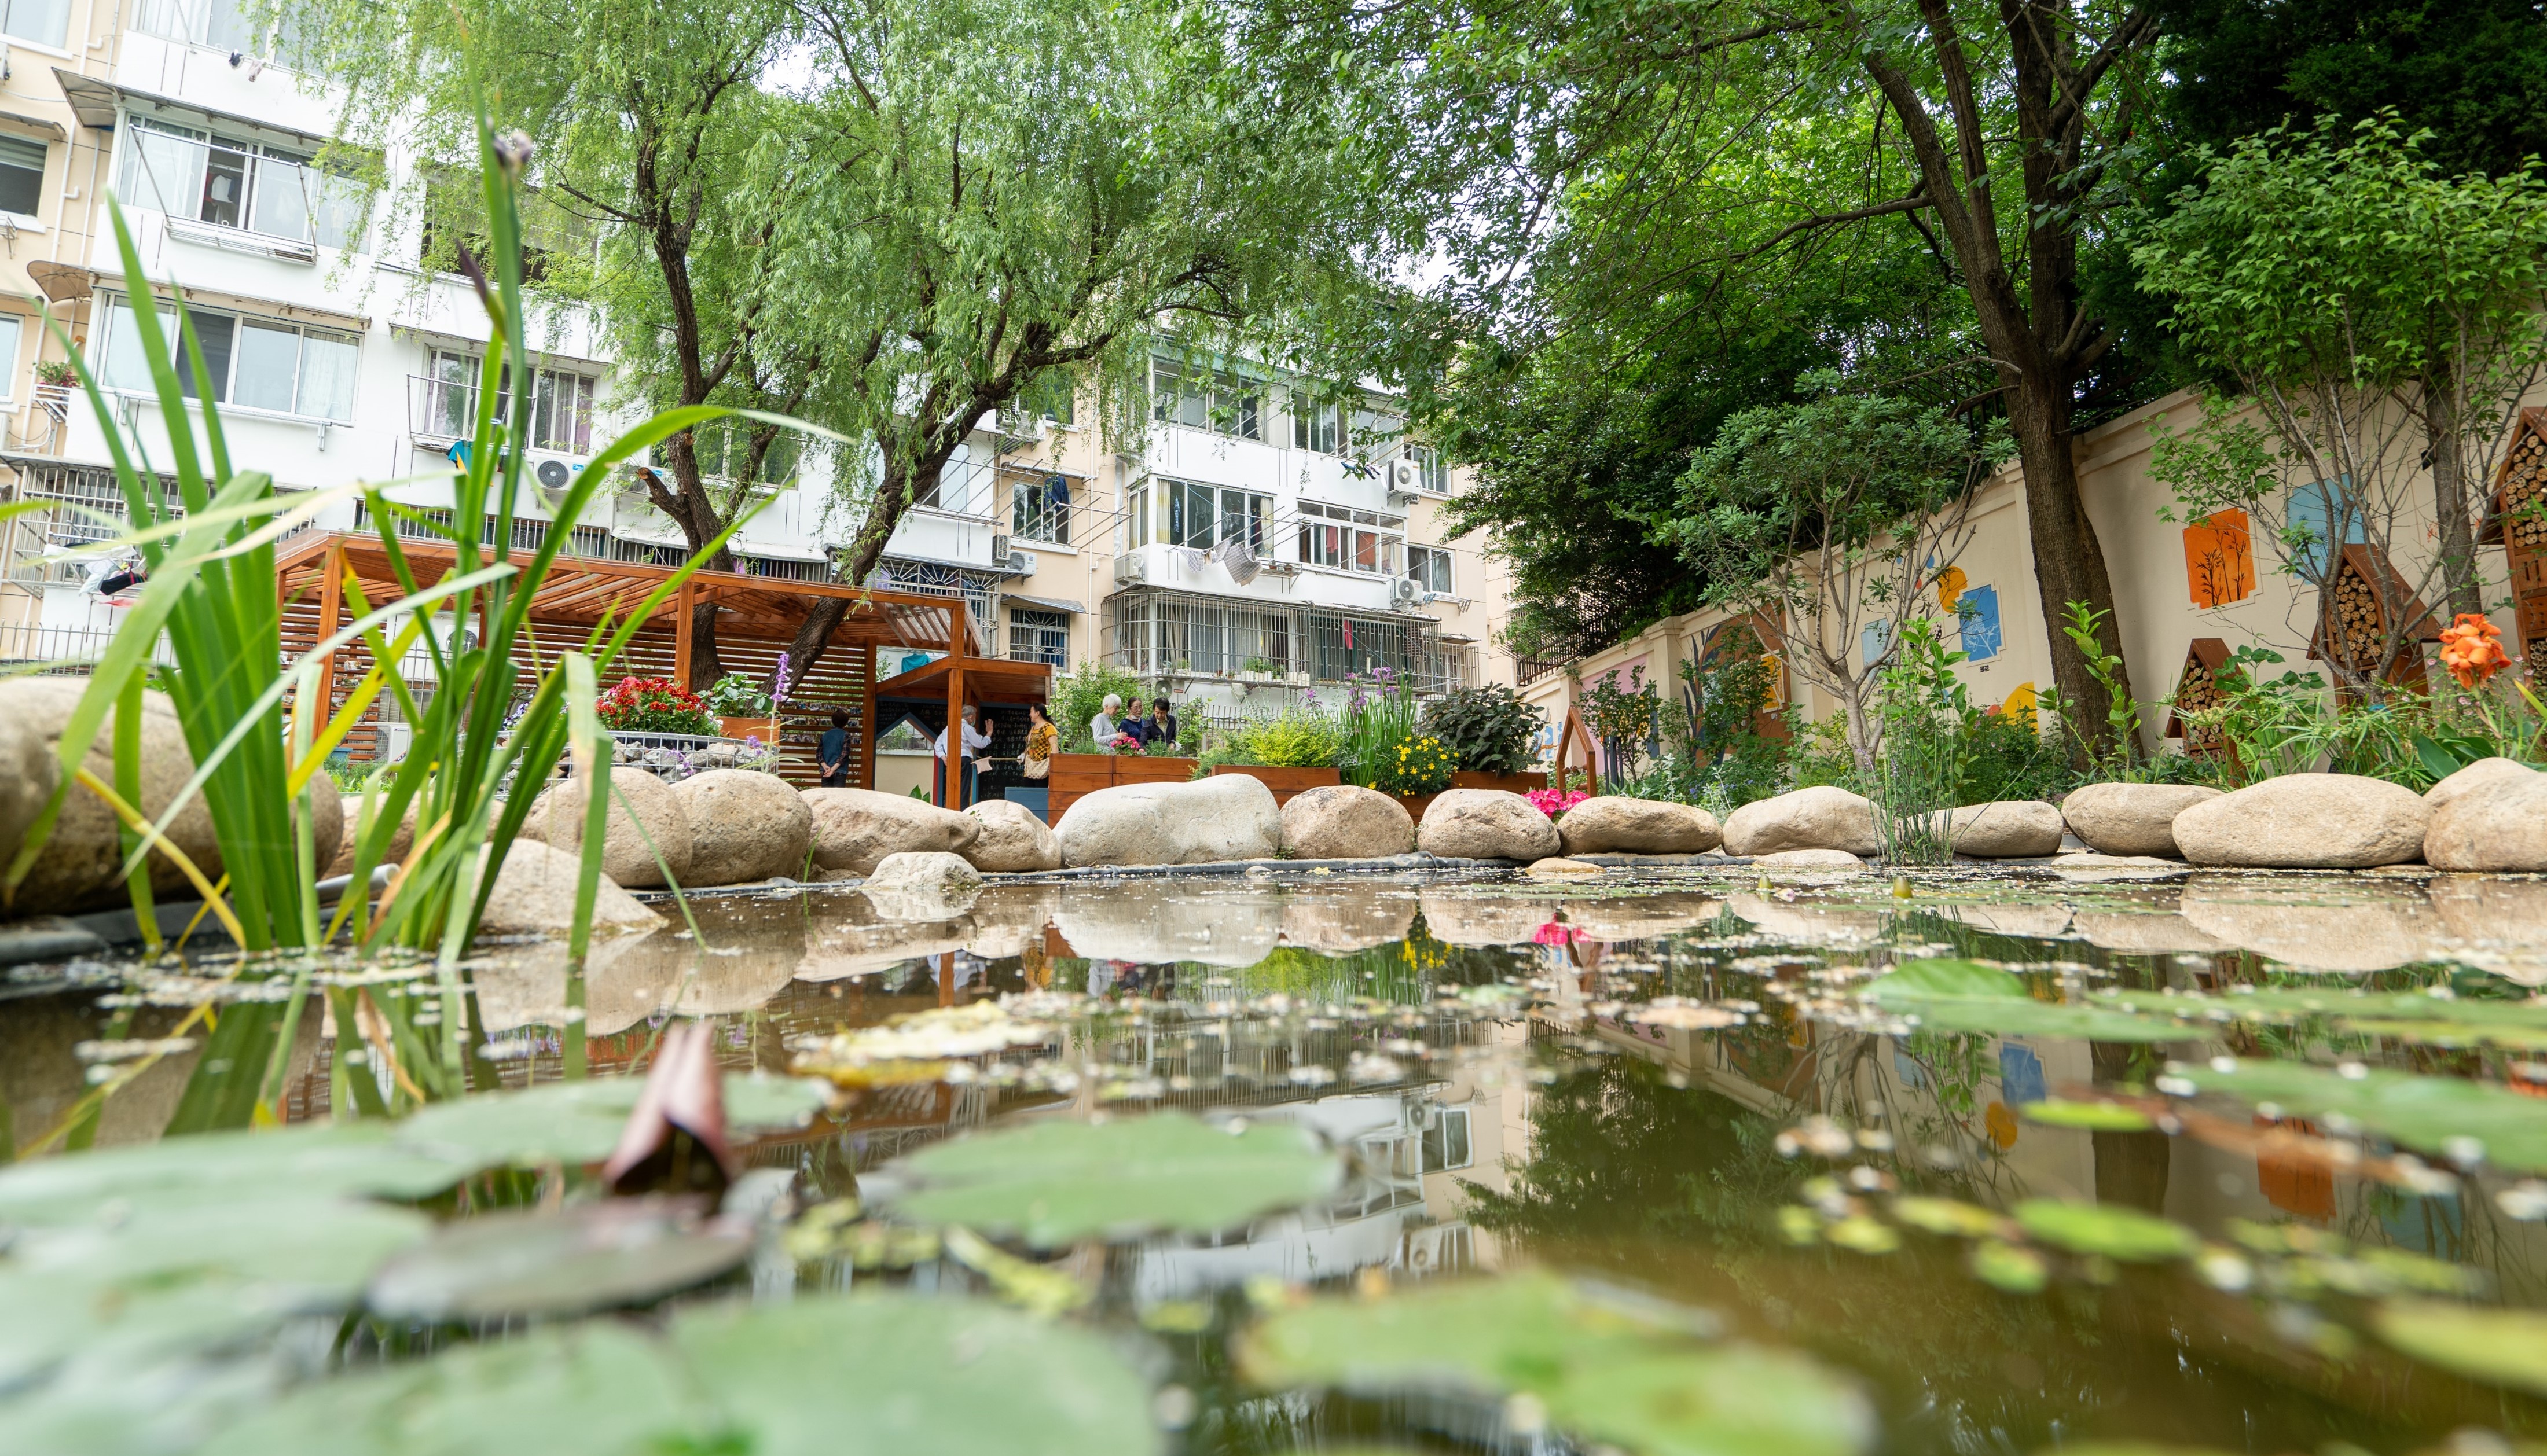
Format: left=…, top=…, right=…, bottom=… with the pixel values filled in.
left=0, top=677, right=224, bottom=914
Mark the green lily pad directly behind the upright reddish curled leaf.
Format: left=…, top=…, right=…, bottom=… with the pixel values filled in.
left=397, top=1077, right=828, bottom=1166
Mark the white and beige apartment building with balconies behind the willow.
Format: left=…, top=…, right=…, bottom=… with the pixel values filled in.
left=0, top=0, right=1510, bottom=705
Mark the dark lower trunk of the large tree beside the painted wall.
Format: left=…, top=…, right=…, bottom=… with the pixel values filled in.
left=2007, top=377, right=2142, bottom=759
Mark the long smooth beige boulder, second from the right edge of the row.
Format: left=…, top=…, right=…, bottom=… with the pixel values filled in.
left=2170, top=774, right=2432, bottom=865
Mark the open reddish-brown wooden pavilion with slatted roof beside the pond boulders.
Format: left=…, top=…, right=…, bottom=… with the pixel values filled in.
left=275, top=532, right=1052, bottom=810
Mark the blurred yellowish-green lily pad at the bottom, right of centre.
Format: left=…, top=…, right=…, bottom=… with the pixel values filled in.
left=1238, top=1273, right=1874, bottom=1456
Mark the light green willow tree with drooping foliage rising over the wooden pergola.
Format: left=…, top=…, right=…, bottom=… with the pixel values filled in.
left=313, top=0, right=1355, bottom=679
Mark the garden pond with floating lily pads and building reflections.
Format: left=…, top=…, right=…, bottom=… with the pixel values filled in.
left=0, top=866, right=2547, bottom=1456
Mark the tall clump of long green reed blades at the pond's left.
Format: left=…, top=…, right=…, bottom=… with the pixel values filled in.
left=0, top=115, right=835, bottom=1133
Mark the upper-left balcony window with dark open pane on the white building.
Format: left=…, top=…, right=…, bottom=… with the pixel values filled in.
left=122, top=117, right=372, bottom=247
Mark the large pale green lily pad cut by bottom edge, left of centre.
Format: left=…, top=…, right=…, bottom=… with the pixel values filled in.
left=672, top=1296, right=1159, bottom=1456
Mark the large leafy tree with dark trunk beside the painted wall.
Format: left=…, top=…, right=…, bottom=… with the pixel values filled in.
left=1253, top=0, right=2157, bottom=758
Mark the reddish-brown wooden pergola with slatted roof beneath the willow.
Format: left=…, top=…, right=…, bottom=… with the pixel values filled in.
left=275, top=532, right=1052, bottom=810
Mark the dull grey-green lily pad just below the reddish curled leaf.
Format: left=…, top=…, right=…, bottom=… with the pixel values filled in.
left=364, top=1199, right=751, bottom=1323
